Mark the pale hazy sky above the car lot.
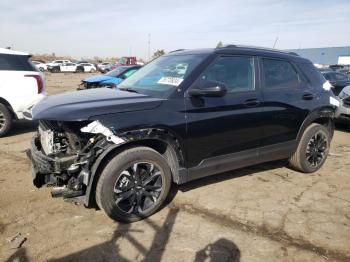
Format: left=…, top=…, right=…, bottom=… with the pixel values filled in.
left=0, top=0, right=350, bottom=58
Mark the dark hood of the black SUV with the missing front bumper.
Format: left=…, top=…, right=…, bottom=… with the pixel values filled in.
left=32, top=88, right=163, bottom=121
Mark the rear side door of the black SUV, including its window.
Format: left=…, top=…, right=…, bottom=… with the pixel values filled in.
left=259, top=58, right=317, bottom=147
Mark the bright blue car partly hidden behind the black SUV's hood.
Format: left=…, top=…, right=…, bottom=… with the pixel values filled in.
left=78, top=65, right=141, bottom=90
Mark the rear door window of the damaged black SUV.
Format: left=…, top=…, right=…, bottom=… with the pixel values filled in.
left=262, top=58, right=299, bottom=88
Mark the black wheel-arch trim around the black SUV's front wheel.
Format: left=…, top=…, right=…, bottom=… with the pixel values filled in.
left=84, top=128, right=184, bottom=206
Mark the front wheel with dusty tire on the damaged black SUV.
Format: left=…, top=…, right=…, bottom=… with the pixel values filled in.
left=96, top=147, right=171, bottom=223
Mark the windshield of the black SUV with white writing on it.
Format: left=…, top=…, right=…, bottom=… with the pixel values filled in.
left=119, top=55, right=205, bottom=98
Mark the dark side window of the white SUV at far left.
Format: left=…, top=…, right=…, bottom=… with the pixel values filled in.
left=0, top=54, right=37, bottom=71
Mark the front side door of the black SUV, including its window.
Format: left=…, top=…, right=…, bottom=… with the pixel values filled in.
left=185, top=56, right=263, bottom=167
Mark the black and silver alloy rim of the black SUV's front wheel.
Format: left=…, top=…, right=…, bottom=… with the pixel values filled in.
left=114, top=162, right=163, bottom=215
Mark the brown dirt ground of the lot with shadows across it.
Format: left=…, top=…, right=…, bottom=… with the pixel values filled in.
left=0, top=74, right=350, bottom=261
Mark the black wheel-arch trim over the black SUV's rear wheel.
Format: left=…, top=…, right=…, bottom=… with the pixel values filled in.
left=297, top=106, right=336, bottom=142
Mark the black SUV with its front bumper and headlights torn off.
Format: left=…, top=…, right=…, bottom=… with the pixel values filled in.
left=27, top=45, right=337, bottom=222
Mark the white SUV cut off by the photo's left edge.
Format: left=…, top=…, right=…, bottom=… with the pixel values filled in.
left=0, top=48, right=46, bottom=137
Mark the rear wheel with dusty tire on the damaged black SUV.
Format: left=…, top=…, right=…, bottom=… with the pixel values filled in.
left=289, top=123, right=331, bottom=173
